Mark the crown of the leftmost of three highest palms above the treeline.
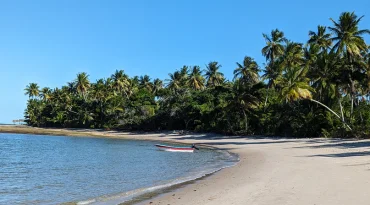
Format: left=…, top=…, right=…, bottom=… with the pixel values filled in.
left=262, top=29, right=286, bottom=64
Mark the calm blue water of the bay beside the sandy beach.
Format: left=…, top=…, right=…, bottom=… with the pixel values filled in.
left=0, top=133, right=237, bottom=204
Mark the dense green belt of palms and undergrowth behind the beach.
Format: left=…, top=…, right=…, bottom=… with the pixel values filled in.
left=25, top=12, right=370, bottom=137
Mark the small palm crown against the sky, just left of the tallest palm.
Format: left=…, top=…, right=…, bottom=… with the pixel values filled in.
left=308, top=25, right=332, bottom=50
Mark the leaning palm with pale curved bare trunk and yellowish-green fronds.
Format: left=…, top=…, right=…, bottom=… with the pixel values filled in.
left=279, top=67, right=352, bottom=130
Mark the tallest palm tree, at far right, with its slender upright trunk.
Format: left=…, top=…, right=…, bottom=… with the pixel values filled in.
left=329, top=12, right=370, bottom=115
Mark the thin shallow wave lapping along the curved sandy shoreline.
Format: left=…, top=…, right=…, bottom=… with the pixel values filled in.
left=77, top=150, right=239, bottom=205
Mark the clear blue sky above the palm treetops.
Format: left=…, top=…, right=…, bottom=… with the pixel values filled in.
left=0, top=0, right=370, bottom=123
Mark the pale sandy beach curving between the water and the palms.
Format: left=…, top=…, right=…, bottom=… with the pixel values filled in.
left=0, top=126, right=370, bottom=205
